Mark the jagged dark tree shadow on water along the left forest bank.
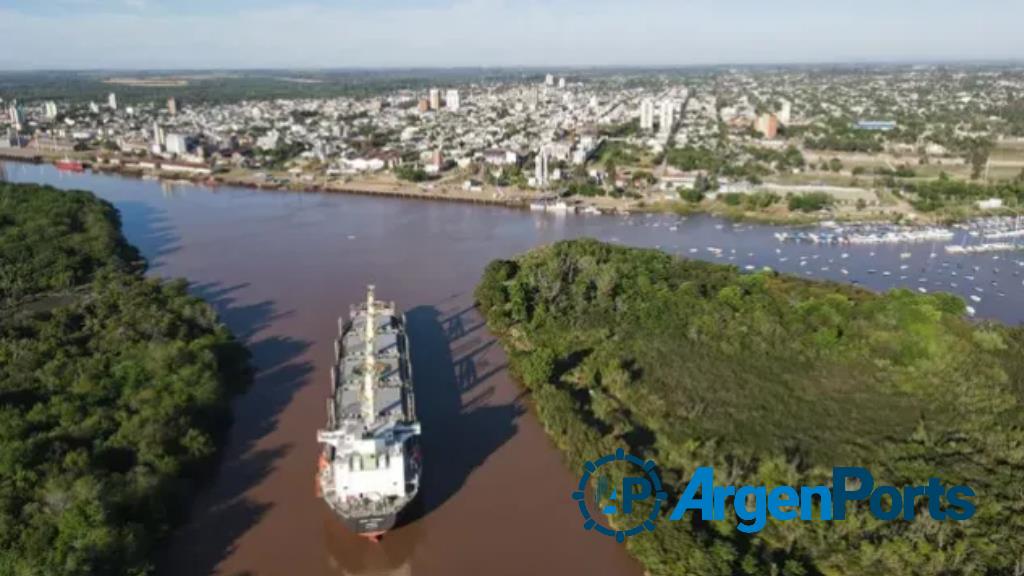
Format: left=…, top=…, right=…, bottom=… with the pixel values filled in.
left=158, top=284, right=312, bottom=576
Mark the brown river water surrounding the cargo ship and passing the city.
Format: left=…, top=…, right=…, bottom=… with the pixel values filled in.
left=4, top=163, right=1024, bottom=576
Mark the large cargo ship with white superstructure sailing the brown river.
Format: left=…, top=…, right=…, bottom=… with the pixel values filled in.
left=316, top=286, right=422, bottom=540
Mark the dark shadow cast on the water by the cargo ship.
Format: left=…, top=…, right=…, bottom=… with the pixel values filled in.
left=402, top=306, right=525, bottom=522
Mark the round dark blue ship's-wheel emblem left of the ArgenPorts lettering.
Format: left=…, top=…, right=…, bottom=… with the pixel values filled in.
left=572, top=448, right=668, bottom=542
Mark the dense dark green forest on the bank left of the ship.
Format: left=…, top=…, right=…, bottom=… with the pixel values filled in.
left=0, top=184, right=250, bottom=576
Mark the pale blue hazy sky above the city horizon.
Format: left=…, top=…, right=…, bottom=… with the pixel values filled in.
left=0, top=0, right=1024, bottom=70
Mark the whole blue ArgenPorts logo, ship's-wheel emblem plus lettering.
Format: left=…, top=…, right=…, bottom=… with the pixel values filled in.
left=572, top=449, right=975, bottom=542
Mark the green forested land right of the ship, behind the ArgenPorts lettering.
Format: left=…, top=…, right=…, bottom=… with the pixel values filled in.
left=476, top=240, right=1024, bottom=576
